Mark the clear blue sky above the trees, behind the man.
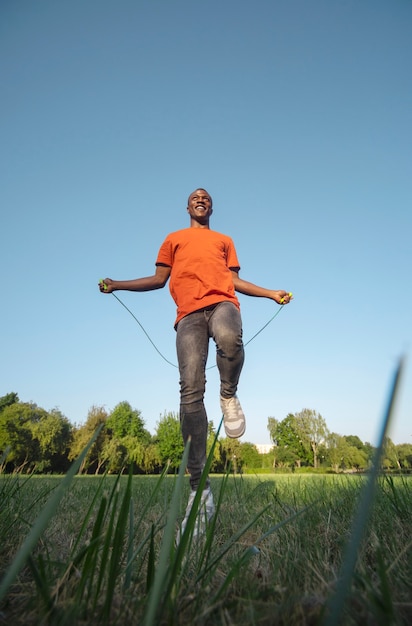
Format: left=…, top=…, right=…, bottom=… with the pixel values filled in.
left=0, top=0, right=412, bottom=443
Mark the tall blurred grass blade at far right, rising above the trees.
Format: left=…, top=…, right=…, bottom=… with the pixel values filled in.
left=322, top=358, right=404, bottom=626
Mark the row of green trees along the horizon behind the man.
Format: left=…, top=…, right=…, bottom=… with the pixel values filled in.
left=0, top=392, right=412, bottom=474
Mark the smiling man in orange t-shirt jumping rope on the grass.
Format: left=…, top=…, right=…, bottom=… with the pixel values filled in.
left=99, top=188, right=292, bottom=532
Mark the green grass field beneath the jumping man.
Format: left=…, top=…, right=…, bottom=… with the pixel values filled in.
left=0, top=471, right=412, bottom=626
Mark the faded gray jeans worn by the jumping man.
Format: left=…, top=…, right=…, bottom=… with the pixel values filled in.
left=176, top=302, right=244, bottom=489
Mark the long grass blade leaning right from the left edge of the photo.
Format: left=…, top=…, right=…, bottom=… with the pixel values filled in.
left=0, top=426, right=102, bottom=601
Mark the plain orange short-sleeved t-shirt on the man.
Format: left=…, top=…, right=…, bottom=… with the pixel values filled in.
left=156, top=228, right=240, bottom=325
